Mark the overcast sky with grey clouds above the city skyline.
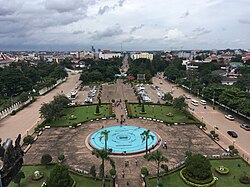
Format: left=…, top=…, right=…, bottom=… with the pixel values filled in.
left=0, top=0, right=250, bottom=50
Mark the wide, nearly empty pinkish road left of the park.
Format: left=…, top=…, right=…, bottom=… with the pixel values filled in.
left=0, top=74, right=80, bottom=141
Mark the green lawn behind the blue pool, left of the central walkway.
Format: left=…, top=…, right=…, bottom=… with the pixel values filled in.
left=46, top=104, right=110, bottom=127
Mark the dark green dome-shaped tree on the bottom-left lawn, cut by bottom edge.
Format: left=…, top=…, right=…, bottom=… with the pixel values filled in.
left=47, top=164, right=72, bottom=187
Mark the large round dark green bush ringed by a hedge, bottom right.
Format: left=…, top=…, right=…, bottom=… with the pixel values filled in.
left=185, top=154, right=212, bottom=180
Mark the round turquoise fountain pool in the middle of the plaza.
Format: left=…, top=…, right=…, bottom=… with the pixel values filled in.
left=87, top=126, right=160, bottom=155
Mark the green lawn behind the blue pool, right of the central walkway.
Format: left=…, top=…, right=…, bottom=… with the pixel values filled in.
left=129, top=104, right=195, bottom=123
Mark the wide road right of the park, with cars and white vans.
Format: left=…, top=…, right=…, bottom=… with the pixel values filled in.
left=152, top=77, right=250, bottom=162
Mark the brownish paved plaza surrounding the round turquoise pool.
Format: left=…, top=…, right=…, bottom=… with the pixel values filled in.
left=25, top=119, right=223, bottom=186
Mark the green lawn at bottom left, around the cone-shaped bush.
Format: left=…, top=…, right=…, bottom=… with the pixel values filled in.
left=9, top=166, right=109, bottom=187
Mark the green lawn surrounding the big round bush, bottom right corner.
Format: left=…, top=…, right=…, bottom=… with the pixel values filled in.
left=148, top=159, right=250, bottom=187
